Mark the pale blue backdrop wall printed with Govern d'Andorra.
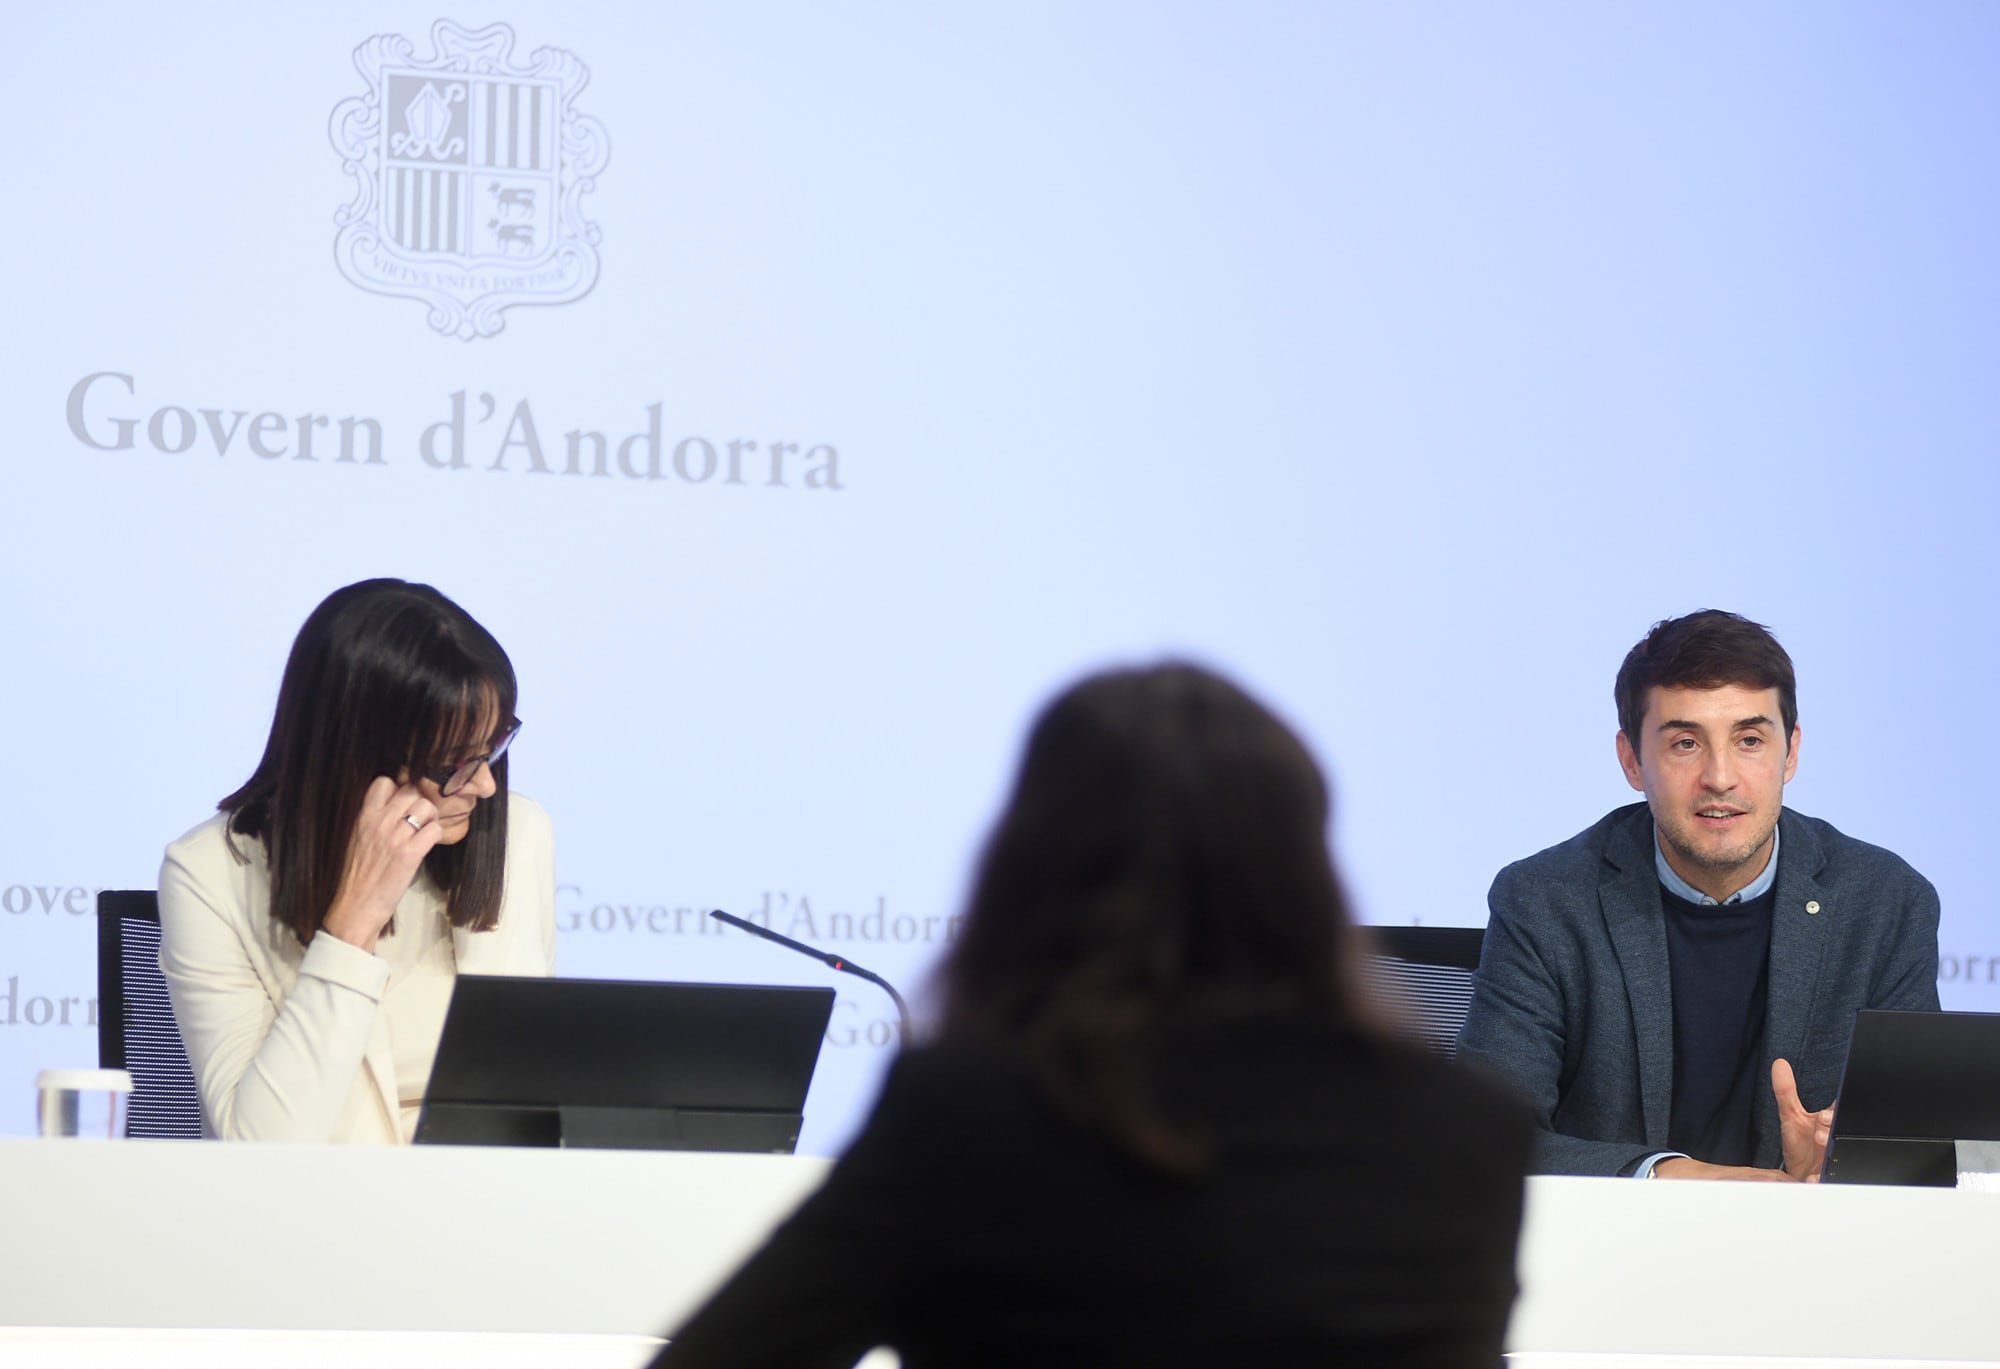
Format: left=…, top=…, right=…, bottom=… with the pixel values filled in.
left=0, top=0, right=2000, bottom=1151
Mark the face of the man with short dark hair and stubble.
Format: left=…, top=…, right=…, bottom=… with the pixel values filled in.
left=1618, top=685, right=1798, bottom=901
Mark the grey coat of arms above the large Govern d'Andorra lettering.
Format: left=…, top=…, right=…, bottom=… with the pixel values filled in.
left=330, top=20, right=610, bottom=340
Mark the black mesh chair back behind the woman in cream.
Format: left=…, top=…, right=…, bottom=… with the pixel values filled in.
left=98, top=889, right=202, bottom=1141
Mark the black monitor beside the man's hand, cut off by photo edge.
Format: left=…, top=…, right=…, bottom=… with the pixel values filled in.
left=1820, top=1009, right=2000, bottom=1187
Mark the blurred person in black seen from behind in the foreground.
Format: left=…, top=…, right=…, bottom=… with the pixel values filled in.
left=656, top=664, right=1534, bottom=1369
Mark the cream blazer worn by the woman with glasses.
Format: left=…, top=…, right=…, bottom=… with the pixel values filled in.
left=160, top=795, right=556, bottom=1143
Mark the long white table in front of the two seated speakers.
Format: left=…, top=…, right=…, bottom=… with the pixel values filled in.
left=0, top=1139, right=2000, bottom=1369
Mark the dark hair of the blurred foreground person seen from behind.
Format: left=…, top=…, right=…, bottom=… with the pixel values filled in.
left=940, top=664, right=1372, bottom=1173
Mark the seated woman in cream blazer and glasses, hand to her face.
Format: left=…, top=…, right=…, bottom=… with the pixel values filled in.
left=160, top=580, right=556, bottom=1145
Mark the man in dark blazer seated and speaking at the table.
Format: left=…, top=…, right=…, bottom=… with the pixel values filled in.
left=1458, top=610, right=1938, bottom=1179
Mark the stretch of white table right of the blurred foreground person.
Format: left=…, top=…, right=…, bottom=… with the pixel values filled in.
left=1508, top=1179, right=2000, bottom=1369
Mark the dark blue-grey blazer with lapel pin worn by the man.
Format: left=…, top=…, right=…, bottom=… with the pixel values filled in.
left=1458, top=803, right=1938, bottom=1175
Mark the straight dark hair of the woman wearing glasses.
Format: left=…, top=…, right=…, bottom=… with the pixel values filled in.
left=216, top=580, right=516, bottom=943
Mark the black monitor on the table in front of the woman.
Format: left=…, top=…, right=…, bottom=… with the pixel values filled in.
left=416, top=975, right=834, bottom=1155
